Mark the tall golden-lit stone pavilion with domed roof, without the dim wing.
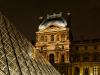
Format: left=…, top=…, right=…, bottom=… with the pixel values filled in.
left=35, top=13, right=71, bottom=75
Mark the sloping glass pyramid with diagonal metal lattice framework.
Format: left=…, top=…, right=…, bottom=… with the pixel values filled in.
left=0, top=13, right=60, bottom=75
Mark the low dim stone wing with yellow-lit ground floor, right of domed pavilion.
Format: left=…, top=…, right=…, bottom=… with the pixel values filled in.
left=70, top=39, right=100, bottom=75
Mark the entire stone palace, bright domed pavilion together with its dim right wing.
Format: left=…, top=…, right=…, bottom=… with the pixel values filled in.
left=35, top=13, right=100, bottom=75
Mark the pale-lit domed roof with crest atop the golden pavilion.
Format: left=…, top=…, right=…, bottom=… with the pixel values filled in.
left=39, top=13, right=67, bottom=30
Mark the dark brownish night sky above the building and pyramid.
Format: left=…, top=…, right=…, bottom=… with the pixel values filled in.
left=0, top=0, right=100, bottom=40
